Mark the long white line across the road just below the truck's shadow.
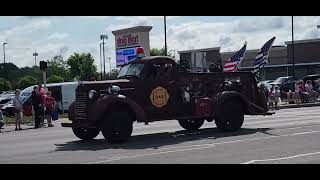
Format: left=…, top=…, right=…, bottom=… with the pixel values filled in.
left=85, top=131, right=320, bottom=164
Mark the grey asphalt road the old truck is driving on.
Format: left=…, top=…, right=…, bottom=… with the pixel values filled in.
left=0, top=107, right=320, bottom=164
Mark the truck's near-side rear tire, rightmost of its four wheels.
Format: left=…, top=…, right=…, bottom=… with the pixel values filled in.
left=215, top=99, right=244, bottom=132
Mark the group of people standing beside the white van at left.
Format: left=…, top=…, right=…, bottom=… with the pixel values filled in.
left=13, top=84, right=56, bottom=131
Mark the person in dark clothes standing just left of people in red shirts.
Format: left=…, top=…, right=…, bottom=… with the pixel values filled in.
left=31, top=86, right=41, bottom=128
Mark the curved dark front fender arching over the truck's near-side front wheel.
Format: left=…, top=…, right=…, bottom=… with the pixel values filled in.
left=89, top=94, right=147, bottom=122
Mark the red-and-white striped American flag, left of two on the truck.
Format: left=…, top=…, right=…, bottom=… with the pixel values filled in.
left=223, top=42, right=247, bottom=72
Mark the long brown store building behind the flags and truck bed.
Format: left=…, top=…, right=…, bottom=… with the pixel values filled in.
left=179, top=39, right=320, bottom=80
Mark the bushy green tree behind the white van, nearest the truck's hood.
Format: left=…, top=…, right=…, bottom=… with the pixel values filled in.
left=67, top=53, right=98, bottom=80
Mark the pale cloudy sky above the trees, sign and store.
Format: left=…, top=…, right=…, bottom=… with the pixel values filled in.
left=0, top=16, right=320, bottom=70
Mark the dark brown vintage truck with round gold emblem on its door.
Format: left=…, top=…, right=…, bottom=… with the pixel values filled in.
left=62, top=47, right=273, bottom=143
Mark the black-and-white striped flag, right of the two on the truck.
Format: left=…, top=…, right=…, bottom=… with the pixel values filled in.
left=254, top=37, right=276, bottom=72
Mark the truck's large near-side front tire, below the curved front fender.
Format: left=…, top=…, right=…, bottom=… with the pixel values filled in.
left=101, top=109, right=133, bottom=143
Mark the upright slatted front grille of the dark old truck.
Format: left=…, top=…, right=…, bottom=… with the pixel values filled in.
left=75, top=92, right=87, bottom=120
